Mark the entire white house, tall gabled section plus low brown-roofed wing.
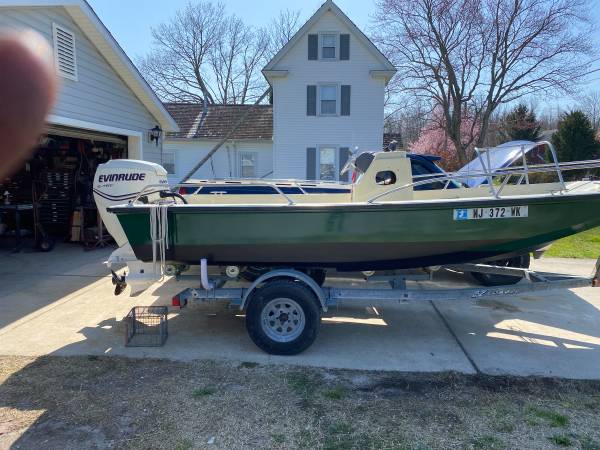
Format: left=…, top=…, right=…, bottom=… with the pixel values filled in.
left=163, top=0, right=396, bottom=184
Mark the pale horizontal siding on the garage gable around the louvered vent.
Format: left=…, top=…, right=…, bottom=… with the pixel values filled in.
left=0, top=6, right=160, bottom=161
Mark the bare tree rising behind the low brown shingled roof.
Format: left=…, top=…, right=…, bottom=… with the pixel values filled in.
left=139, top=1, right=269, bottom=107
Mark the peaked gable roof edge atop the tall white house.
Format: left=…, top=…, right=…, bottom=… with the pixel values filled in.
left=263, top=0, right=396, bottom=77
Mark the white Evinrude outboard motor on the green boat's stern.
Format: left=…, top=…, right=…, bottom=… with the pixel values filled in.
left=94, top=159, right=169, bottom=295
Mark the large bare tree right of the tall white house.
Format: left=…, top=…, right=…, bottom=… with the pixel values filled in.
left=375, top=0, right=592, bottom=164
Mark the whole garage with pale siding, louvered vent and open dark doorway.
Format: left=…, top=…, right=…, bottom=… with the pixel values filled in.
left=0, top=0, right=179, bottom=251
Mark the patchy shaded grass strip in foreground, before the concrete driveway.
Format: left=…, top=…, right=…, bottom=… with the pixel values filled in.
left=0, top=356, right=600, bottom=450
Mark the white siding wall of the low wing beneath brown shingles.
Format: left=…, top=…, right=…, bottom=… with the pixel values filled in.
left=159, top=139, right=273, bottom=183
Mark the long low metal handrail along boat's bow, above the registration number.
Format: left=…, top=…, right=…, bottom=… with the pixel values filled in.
left=367, top=159, right=600, bottom=203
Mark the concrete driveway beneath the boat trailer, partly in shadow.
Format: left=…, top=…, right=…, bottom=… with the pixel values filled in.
left=0, top=245, right=600, bottom=379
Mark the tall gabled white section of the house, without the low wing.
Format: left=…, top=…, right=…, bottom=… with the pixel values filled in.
left=263, top=0, right=396, bottom=180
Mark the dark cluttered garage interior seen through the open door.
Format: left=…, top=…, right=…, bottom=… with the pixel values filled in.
left=0, top=125, right=127, bottom=251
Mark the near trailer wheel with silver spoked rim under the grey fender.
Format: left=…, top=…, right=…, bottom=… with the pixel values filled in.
left=246, top=279, right=321, bottom=355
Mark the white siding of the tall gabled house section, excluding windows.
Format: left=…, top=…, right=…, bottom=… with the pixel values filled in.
left=273, top=12, right=385, bottom=178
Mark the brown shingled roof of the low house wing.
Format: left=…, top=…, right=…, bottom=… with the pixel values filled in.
left=164, top=103, right=273, bottom=140
